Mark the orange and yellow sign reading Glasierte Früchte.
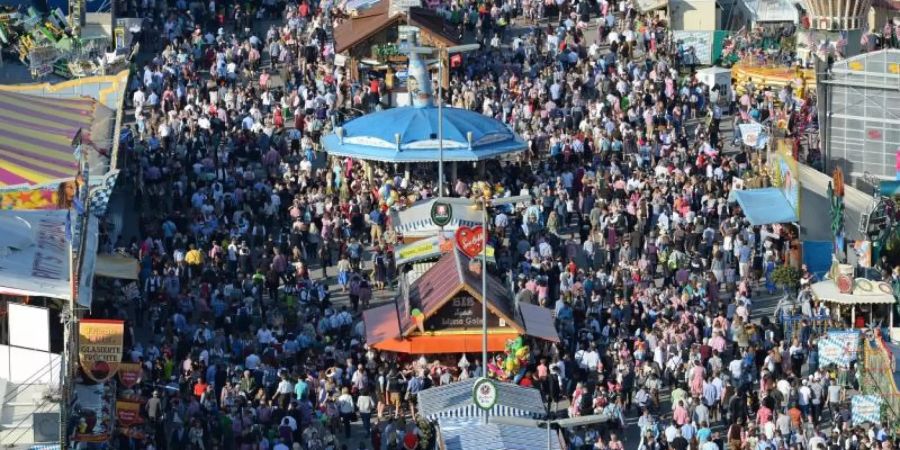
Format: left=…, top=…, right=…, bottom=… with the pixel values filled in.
left=78, top=319, right=125, bottom=383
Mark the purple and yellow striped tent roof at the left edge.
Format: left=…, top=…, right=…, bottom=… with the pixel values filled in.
left=0, top=92, right=114, bottom=186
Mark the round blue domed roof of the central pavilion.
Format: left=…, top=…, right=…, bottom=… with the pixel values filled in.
left=323, top=106, right=526, bottom=162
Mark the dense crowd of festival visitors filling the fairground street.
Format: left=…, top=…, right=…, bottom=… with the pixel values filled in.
left=72, top=0, right=891, bottom=450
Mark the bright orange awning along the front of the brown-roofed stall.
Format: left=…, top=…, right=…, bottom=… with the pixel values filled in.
left=366, top=332, right=519, bottom=355
